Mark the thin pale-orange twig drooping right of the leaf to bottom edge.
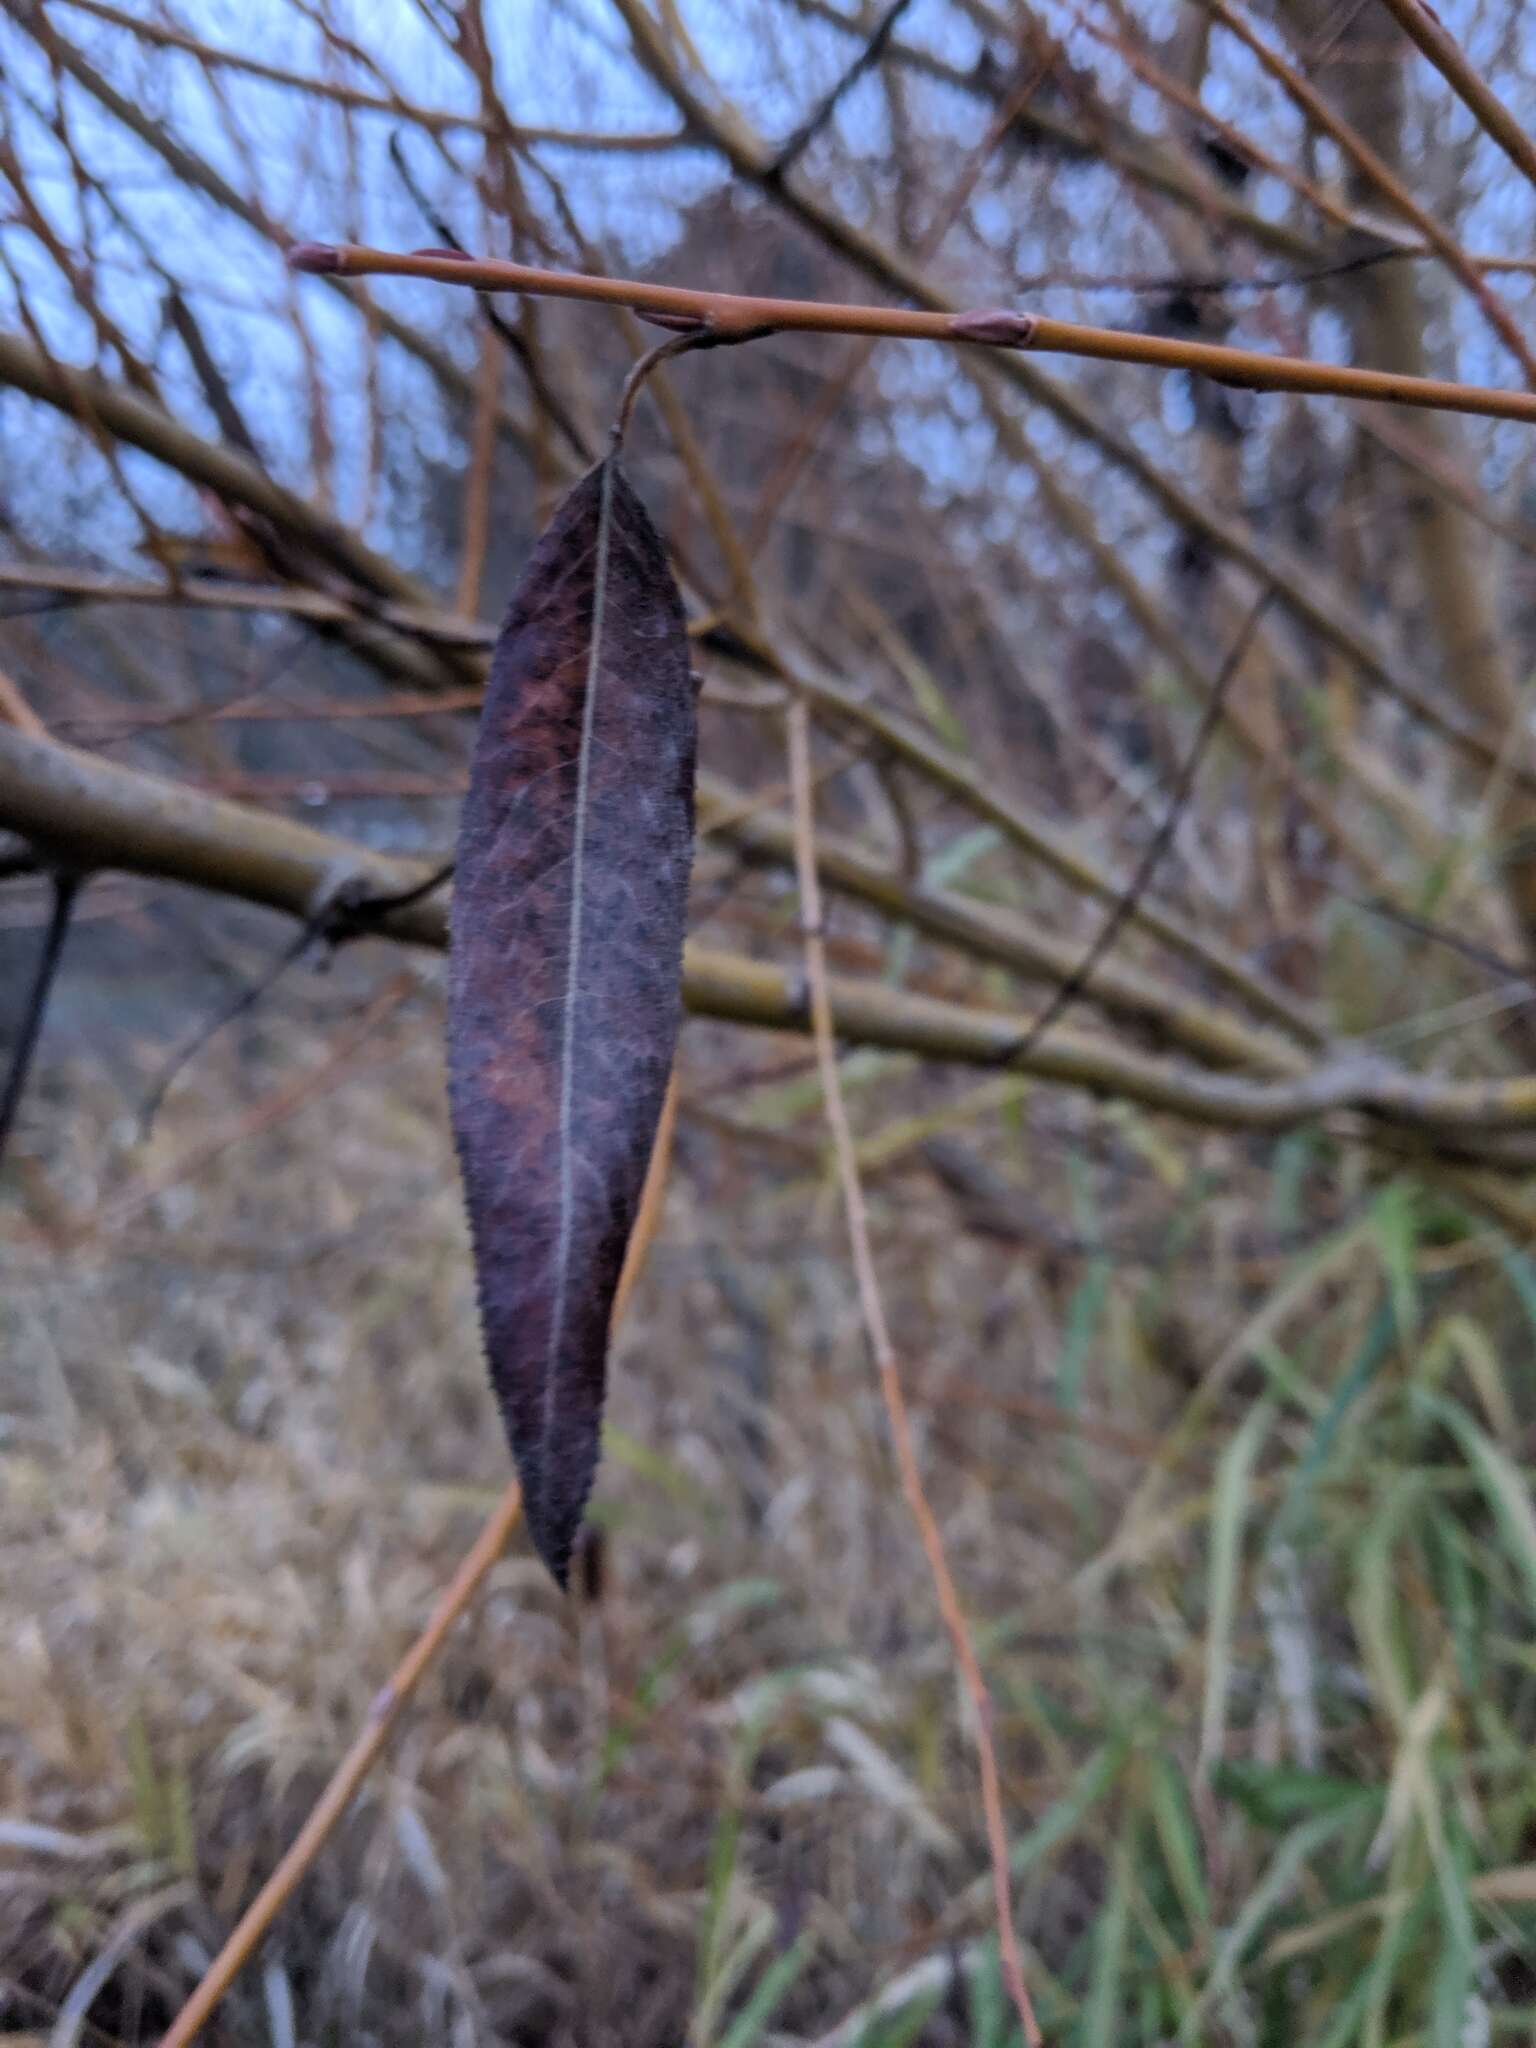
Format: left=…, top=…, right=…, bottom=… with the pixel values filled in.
left=786, top=698, right=1042, bottom=2048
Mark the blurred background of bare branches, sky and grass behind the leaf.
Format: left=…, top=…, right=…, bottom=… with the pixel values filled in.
left=0, top=0, right=1536, bottom=2048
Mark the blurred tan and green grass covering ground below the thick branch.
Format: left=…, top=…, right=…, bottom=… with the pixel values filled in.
left=0, top=892, right=1536, bottom=2048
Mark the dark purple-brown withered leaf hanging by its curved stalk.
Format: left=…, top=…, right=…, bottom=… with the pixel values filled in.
left=449, top=457, right=696, bottom=1585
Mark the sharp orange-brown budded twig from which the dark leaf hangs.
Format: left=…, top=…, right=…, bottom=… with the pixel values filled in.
left=289, top=242, right=1536, bottom=424
